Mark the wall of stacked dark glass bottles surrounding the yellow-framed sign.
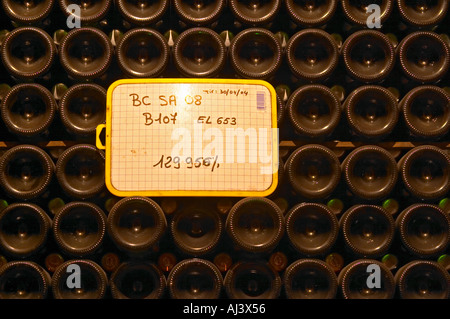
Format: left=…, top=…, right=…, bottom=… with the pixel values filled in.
left=0, top=0, right=450, bottom=299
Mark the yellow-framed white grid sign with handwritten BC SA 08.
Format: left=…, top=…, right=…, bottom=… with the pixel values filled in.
left=96, top=79, right=278, bottom=197
